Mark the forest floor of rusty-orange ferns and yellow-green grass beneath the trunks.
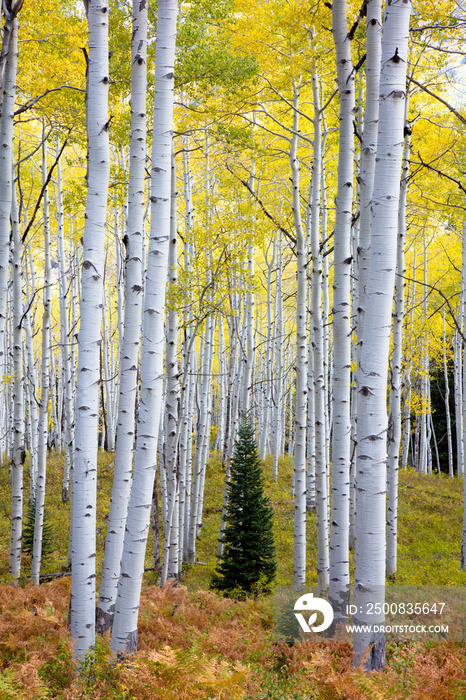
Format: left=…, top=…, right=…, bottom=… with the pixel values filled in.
left=0, top=453, right=466, bottom=700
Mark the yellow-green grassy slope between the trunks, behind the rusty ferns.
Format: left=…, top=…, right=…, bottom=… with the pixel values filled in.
left=0, top=451, right=466, bottom=590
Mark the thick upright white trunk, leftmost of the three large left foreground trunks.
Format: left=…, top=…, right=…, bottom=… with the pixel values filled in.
left=70, top=0, right=110, bottom=658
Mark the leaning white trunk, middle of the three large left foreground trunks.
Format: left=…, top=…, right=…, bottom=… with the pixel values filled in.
left=96, top=0, right=147, bottom=633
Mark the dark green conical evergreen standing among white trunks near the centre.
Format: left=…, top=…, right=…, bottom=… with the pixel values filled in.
left=211, top=416, right=277, bottom=595
